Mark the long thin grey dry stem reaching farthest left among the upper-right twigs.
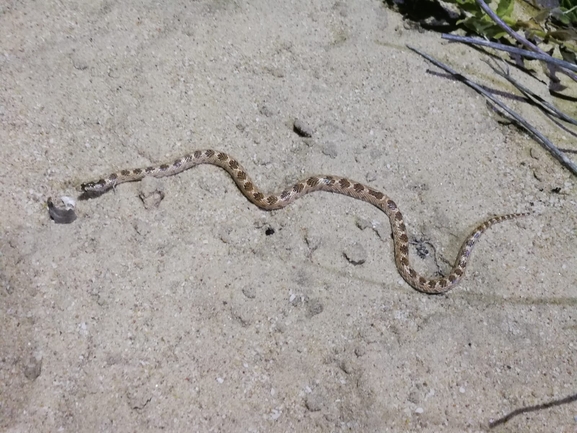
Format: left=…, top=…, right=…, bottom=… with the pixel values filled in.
left=407, top=45, right=577, bottom=176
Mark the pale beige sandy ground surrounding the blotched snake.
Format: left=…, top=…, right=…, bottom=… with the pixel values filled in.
left=0, top=0, right=577, bottom=432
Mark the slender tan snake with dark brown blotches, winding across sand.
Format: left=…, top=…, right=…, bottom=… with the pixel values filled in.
left=81, top=149, right=529, bottom=294
